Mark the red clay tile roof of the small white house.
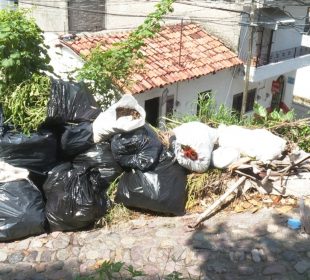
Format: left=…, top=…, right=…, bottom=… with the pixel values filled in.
left=61, top=23, right=242, bottom=94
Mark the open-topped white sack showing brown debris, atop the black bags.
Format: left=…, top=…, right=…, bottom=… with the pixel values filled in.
left=93, top=94, right=145, bottom=143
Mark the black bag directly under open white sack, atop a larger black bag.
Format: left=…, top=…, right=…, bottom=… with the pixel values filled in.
left=111, top=124, right=163, bottom=171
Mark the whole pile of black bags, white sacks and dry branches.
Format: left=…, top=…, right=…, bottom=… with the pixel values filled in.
left=0, top=80, right=310, bottom=241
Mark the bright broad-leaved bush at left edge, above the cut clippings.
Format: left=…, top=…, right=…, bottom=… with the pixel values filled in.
left=0, top=9, right=52, bottom=93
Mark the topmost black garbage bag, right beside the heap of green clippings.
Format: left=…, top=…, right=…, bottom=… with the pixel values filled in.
left=46, top=77, right=101, bottom=124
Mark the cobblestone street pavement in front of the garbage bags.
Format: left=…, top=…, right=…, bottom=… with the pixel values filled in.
left=0, top=208, right=310, bottom=280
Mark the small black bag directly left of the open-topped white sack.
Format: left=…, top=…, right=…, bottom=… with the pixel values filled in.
left=61, top=122, right=94, bottom=158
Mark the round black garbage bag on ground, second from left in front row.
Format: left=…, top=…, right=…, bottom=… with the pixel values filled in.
left=43, top=163, right=109, bottom=231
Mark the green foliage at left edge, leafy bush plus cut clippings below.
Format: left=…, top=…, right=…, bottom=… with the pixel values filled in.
left=0, top=10, right=52, bottom=134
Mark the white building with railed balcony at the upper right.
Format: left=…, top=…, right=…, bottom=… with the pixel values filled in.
left=239, top=1, right=310, bottom=110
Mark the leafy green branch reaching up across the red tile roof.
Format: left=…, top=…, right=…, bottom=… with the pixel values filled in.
left=78, top=0, right=174, bottom=108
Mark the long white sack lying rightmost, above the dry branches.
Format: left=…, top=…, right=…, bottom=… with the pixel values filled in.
left=218, top=125, right=286, bottom=162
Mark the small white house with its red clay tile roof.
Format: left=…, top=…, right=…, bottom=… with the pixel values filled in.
left=57, top=22, right=249, bottom=124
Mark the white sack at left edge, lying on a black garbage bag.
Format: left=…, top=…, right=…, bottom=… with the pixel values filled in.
left=0, top=161, right=29, bottom=183
